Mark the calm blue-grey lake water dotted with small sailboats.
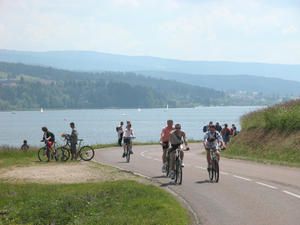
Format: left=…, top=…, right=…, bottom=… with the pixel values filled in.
left=0, top=106, right=259, bottom=146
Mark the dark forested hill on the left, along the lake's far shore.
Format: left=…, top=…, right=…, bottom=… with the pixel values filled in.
left=0, top=62, right=227, bottom=110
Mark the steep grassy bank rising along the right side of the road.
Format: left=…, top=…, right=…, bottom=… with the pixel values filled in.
left=222, top=100, right=300, bottom=167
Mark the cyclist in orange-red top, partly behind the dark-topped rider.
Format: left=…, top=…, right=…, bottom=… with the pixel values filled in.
left=160, top=120, right=174, bottom=173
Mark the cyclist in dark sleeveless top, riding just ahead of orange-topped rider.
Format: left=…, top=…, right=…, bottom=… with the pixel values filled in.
left=169, top=123, right=189, bottom=179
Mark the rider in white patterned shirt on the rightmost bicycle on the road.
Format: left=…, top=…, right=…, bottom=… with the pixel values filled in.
left=203, top=124, right=225, bottom=170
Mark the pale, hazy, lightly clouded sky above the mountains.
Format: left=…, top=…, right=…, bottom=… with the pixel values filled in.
left=0, top=0, right=300, bottom=64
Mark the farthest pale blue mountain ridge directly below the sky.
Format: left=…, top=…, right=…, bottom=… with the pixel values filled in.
left=0, top=50, right=300, bottom=81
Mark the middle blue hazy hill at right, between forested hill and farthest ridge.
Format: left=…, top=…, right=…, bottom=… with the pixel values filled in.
left=141, top=71, right=300, bottom=96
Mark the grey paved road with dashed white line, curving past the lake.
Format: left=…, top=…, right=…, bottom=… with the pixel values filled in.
left=95, top=144, right=300, bottom=225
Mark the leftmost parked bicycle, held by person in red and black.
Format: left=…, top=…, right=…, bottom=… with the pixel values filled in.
left=38, top=141, right=68, bottom=162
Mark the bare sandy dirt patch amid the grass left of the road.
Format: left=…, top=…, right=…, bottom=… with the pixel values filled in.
left=0, top=162, right=137, bottom=183
